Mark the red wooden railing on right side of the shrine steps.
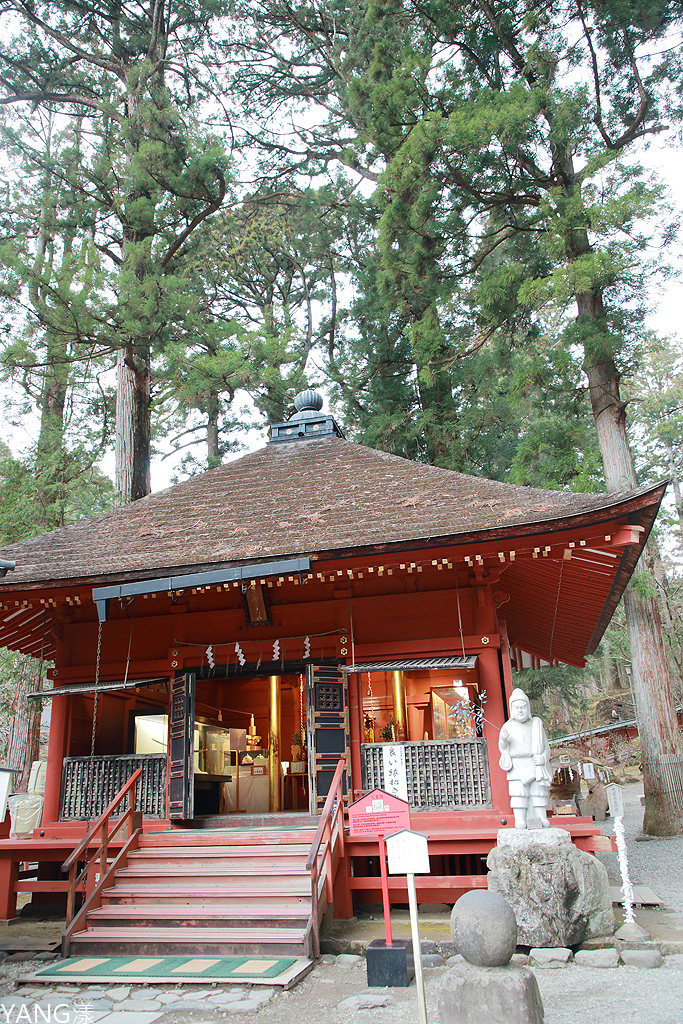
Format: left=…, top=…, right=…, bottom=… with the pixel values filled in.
left=306, top=760, right=346, bottom=957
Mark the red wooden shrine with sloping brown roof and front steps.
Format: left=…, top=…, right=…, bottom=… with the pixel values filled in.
left=0, top=392, right=666, bottom=955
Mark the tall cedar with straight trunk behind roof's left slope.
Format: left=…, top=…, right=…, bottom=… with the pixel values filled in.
left=0, top=0, right=232, bottom=500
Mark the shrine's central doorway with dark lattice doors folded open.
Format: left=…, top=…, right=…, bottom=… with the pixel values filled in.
left=169, top=666, right=351, bottom=825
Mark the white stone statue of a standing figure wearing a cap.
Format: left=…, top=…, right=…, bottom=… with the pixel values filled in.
left=498, top=689, right=552, bottom=828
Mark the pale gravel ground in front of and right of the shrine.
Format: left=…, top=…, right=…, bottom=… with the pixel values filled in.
left=0, top=786, right=683, bottom=1024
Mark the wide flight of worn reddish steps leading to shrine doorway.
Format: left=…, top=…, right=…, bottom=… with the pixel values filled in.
left=71, top=827, right=326, bottom=956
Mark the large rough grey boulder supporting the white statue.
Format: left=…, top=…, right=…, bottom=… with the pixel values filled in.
left=486, top=828, right=614, bottom=946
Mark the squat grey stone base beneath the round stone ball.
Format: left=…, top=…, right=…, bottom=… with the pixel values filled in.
left=436, top=962, right=544, bottom=1024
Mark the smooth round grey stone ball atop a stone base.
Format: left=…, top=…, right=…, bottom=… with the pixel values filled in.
left=451, top=889, right=517, bottom=967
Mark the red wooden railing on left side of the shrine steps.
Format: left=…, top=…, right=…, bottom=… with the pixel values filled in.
left=61, top=768, right=142, bottom=956
